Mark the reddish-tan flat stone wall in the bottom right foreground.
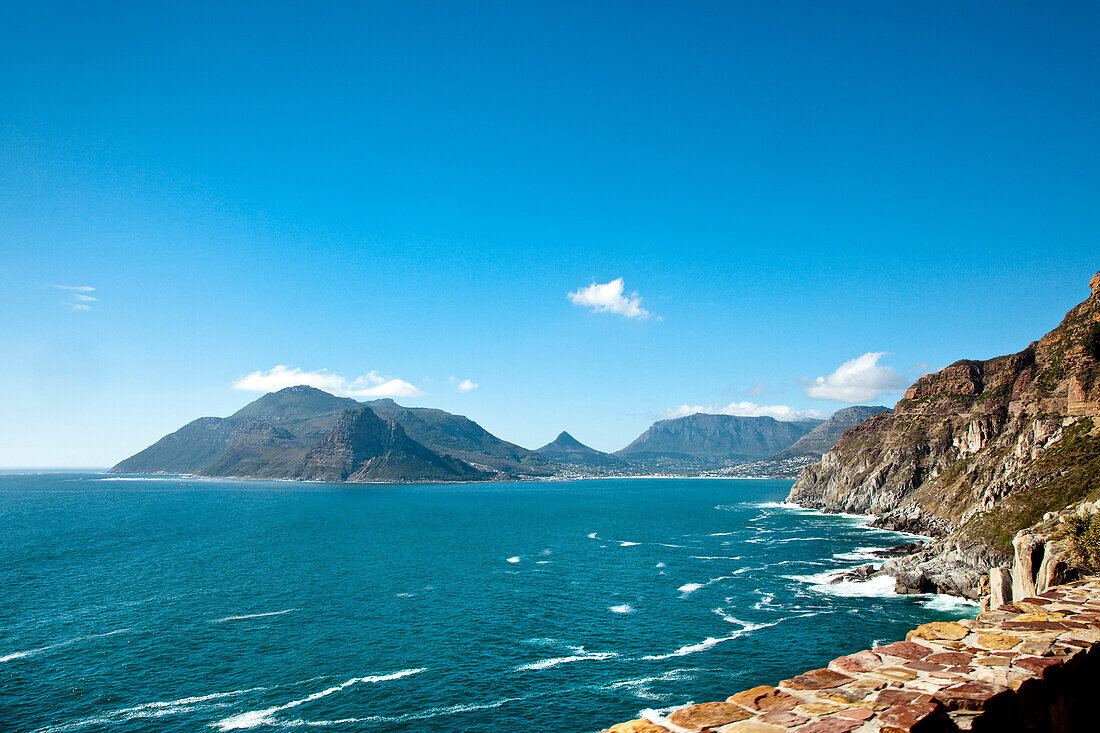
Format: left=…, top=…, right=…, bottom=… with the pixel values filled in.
left=605, top=576, right=1100, bottom=733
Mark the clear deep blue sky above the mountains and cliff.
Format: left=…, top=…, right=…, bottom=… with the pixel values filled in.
left=0, top=1, right=1100, bottom=466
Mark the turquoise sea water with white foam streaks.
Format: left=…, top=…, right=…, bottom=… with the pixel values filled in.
left=0, top=473, right=977, bottom=733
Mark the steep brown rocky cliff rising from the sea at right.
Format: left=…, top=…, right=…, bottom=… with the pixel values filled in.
left=789, top=273, right=1100, bottom=598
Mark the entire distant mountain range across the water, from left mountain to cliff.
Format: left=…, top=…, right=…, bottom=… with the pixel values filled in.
left=111, top=385, right=886, bottom=481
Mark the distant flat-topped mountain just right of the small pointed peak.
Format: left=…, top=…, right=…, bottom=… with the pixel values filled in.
left=615, top=413, right=824, bottom=466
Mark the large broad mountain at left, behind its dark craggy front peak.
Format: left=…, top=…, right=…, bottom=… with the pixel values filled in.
left=111, top=385, right=556, bottom=480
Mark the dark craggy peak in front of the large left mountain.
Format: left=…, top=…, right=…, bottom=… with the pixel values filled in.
left=292, top=407, right=490, bottom=483
